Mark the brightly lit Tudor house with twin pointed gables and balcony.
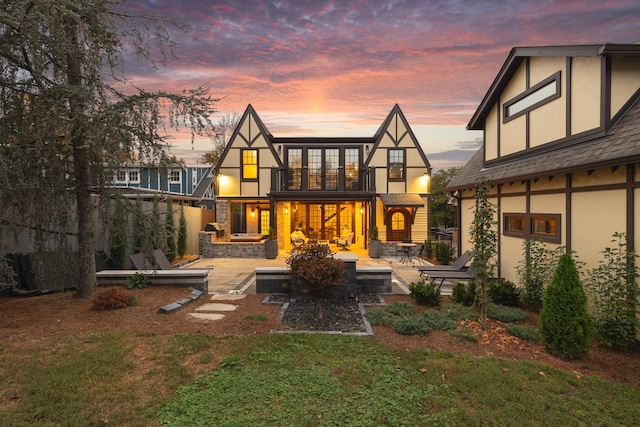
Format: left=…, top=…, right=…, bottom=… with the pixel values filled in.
left=215, top=105, right=431, bottom=248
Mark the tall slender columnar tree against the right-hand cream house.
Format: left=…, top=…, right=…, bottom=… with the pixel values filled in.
left=469, top=179, right=498, bottom=330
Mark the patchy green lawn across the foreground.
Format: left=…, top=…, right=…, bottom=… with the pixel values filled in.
left=0, top=332, right=640, bottom=426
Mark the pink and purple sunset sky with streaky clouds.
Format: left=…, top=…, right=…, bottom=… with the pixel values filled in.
left=127, top=0, right=640, bottom=169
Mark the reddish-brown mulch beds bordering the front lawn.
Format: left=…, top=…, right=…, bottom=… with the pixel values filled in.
left=0, top=287, right=640, bottom=387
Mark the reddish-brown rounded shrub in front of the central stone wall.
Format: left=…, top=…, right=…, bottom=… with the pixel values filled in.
left=286, top=244, right=345, bottom=319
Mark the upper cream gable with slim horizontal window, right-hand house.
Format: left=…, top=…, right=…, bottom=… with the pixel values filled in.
left=467, top=44, right=640, bottom=165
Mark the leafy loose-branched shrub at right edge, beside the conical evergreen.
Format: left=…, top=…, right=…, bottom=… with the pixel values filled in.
left=586, top=233, right=640, bottom=349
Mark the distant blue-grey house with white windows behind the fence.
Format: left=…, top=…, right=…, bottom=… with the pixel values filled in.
left=106, top=163, right=214, bottom=209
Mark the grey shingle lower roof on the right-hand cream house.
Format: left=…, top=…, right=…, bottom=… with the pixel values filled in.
left=448, top=100, right=640, bottom=190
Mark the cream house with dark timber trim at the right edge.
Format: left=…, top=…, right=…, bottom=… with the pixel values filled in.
left=448, top=44, right=640, bottom=282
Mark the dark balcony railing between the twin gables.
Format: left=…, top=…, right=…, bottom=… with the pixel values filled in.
left=271, top=167, right=376, bottom=193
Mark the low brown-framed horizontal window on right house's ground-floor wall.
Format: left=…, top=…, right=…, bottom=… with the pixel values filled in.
left=503, top=213, right=560, bottom=243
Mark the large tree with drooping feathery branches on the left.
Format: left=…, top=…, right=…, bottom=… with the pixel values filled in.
left=0, top=0, right=217, bottom=297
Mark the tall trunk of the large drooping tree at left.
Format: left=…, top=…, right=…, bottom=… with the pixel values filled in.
left=67, top=24, right=96, bottom=298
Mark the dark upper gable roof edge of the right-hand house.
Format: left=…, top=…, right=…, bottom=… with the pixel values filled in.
left=467, top=43, right=640, bottom=130
